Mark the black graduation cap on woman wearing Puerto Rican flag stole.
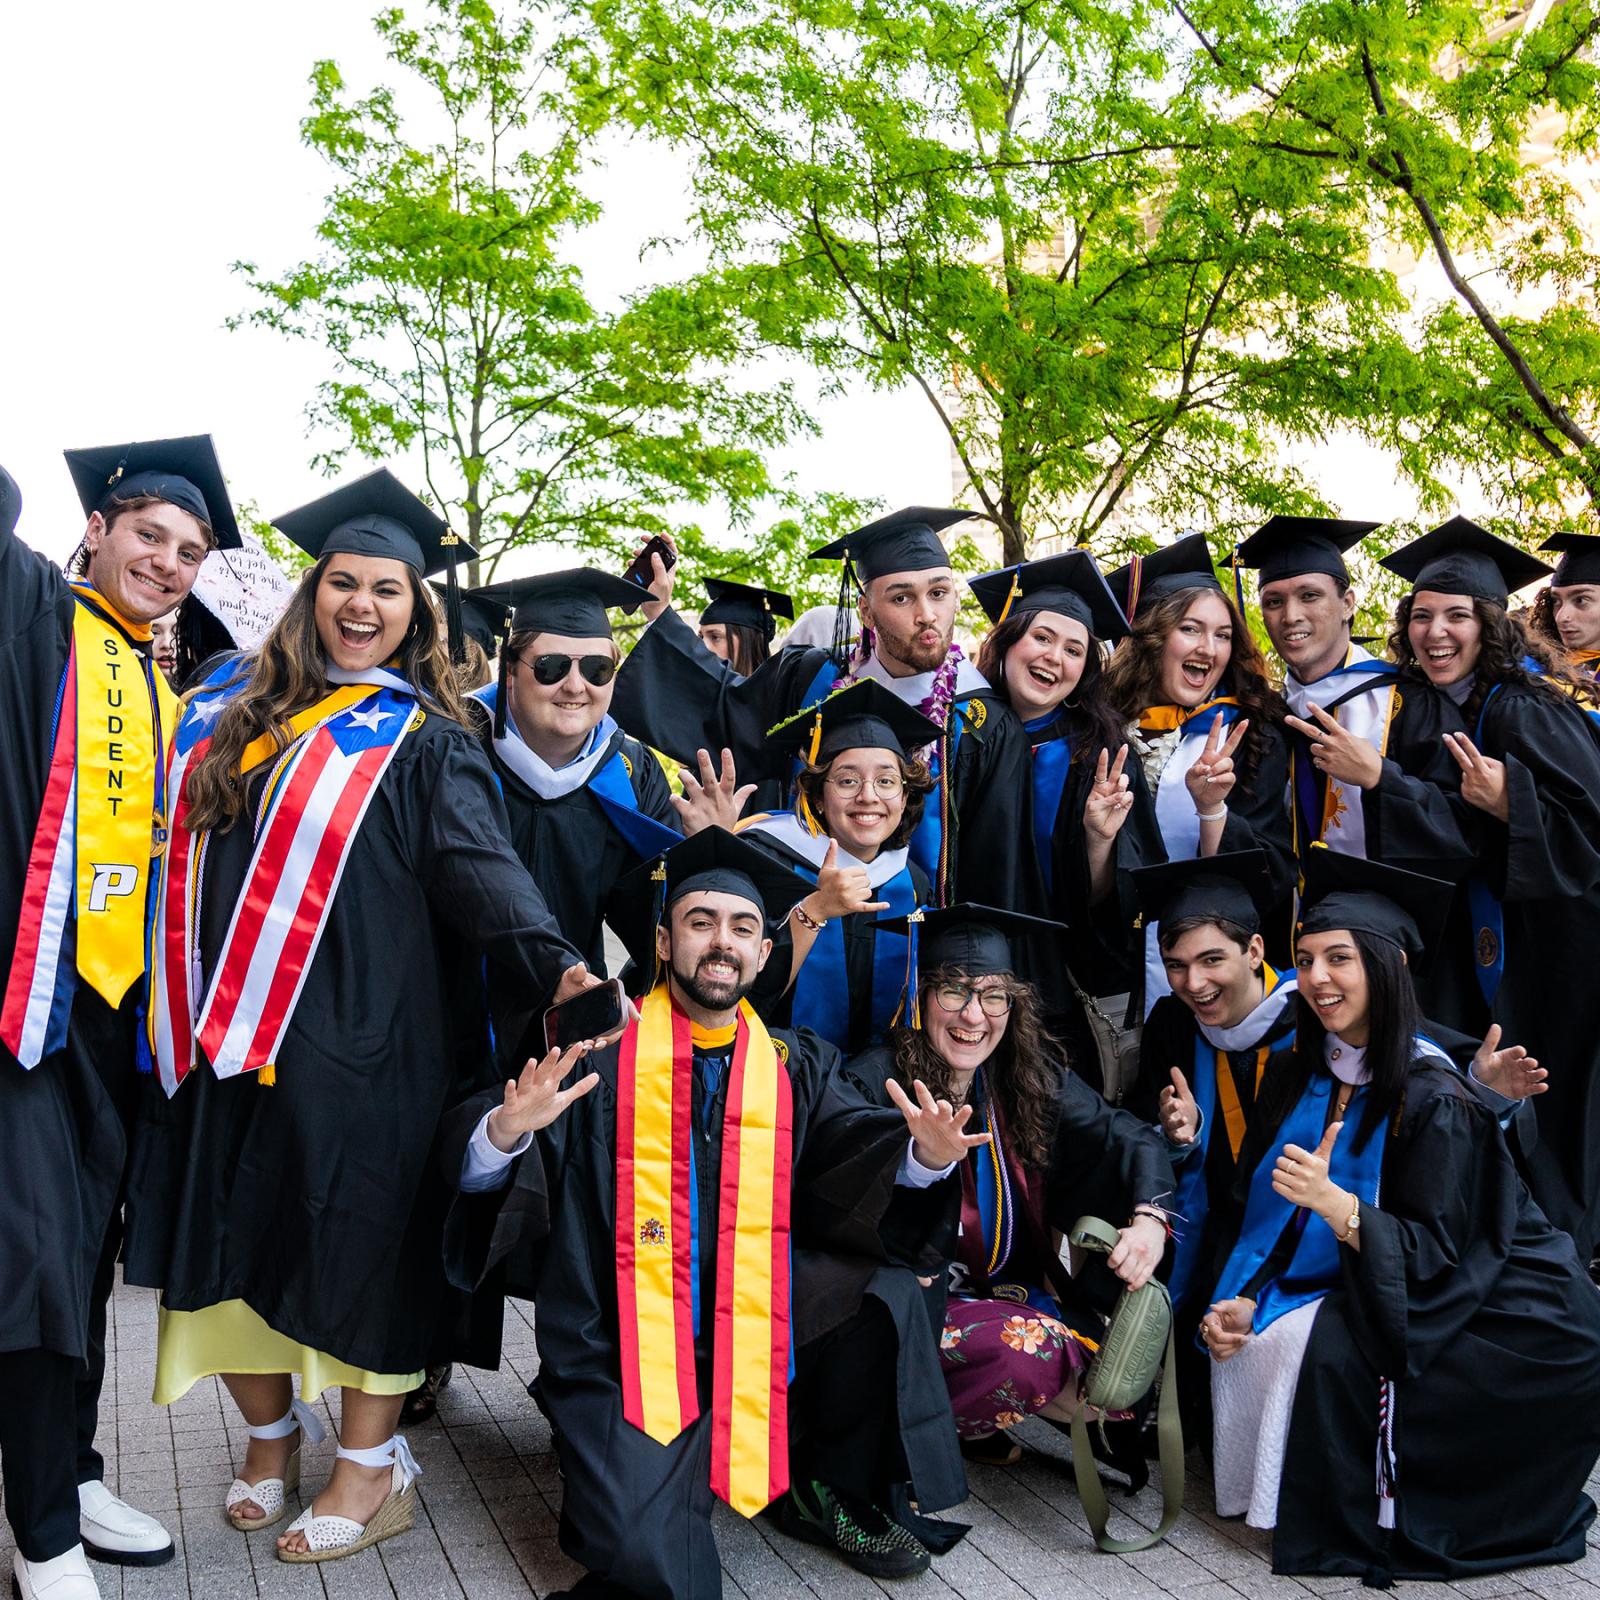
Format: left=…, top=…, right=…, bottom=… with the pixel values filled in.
left=272, top=467, right=478, bottom=666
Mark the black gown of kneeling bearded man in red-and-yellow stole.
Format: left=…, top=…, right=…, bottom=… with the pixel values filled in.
left=442, top=1029, right=944, bottom=1600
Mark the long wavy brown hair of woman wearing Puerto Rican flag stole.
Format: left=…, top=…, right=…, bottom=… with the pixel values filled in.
left=184, top=555, right=467, bottom=834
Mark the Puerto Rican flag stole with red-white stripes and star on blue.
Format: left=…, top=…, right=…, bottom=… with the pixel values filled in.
left=149, top=662, right=422, bottom=1094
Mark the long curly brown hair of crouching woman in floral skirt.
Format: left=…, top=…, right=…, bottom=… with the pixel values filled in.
left=888, top=965, right=1066, bottom=1166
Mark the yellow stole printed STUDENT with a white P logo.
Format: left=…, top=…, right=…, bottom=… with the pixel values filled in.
left=72, top=584, right=178, bottom=1006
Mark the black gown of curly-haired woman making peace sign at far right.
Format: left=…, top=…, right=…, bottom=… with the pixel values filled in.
left=1443, top=685, right=1600, bottom=1261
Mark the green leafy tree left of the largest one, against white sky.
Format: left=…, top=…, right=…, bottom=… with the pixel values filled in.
left=237, top=0, right=803, bottom=571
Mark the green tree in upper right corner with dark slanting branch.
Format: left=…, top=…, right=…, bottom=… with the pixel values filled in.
left=1173, top=0, right=1600, bottom=534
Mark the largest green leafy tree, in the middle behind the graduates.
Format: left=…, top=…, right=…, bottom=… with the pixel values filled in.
left=590, top=0, right=1424, bottom=562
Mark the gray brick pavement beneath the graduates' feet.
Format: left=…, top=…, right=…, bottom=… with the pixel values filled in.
left=0, top=1288, right=1600, bottom=1600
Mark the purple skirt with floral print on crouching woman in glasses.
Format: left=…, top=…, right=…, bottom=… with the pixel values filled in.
left=939, top=1299, right=1098, bottom=1438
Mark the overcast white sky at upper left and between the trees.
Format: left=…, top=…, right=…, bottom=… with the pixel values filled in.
left=0, top=0, right=950, bottom=565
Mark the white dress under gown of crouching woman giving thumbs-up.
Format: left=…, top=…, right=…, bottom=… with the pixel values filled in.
left=1211, top=1299, right=1322, bottom=1528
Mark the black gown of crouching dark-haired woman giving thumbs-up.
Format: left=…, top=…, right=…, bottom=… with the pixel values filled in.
left=1250, top=1066, right=1600, bottom=1581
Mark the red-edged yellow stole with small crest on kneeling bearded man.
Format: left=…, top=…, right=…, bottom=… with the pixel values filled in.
left=616, top=984, right=794, bottom=1517
